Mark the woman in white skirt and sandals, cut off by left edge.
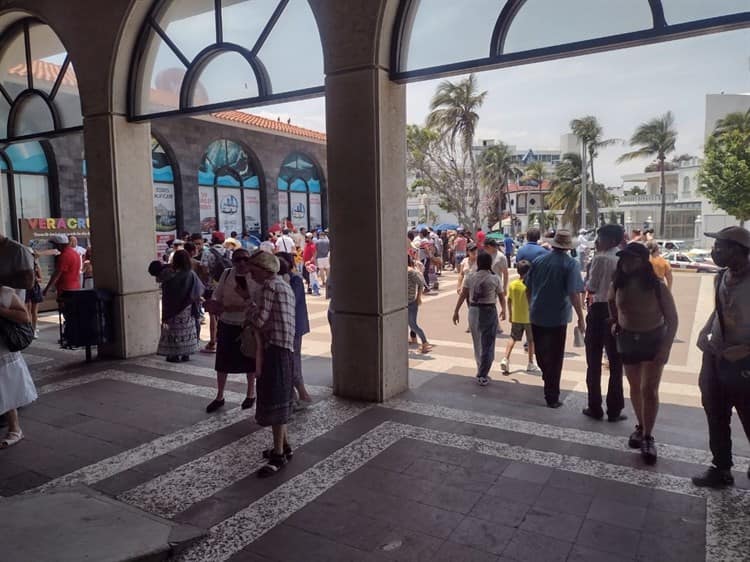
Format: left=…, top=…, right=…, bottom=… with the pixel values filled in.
left=0, top=287, right=37, bottom=449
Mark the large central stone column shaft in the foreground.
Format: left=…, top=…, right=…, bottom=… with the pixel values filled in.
left=326, top=64, right=408, bottom=402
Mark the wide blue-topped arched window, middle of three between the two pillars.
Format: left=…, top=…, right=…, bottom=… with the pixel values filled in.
left=198, top=139, right=261, bottom=236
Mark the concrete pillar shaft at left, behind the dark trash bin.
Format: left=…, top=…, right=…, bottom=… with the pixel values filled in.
left=84, top=114, right=159, bottom=358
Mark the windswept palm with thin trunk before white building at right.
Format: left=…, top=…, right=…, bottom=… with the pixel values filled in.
left=617, top=111, right=677, bottom=236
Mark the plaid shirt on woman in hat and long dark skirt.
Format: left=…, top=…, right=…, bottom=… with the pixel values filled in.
left=252, top=276, right=295, bottom=351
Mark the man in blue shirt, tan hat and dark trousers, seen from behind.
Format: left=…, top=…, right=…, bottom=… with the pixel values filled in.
left=524, top=230, right=586, bottom=408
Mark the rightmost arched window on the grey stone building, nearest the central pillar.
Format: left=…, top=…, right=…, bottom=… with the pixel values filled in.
left=278, top=154, right=323, bottom=230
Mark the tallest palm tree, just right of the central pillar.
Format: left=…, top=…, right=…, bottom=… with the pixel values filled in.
left=426, top=74, right=487, bottom=228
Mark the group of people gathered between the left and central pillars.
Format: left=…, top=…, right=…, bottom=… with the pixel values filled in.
left=148, top=225, right=331, bottom=476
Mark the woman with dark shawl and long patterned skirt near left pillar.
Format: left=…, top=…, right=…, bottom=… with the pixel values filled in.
left=157, top=250, right=204, bottom=363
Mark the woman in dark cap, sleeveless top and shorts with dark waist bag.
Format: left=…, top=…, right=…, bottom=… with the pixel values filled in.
left=609, top=242, right=678, bottom=464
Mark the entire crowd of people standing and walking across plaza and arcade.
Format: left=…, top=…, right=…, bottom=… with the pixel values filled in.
left=0, top=218, right=750, bottom=488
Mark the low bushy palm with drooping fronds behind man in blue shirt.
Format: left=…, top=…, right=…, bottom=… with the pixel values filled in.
left=547, top=153, right=615, bottom=230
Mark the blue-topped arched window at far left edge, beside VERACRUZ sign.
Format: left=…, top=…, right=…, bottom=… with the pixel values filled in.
left=0, top=141, right=57, bottom=240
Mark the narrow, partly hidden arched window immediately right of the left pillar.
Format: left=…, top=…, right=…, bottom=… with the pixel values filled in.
left=151, top=137, right=177, bottom=256
